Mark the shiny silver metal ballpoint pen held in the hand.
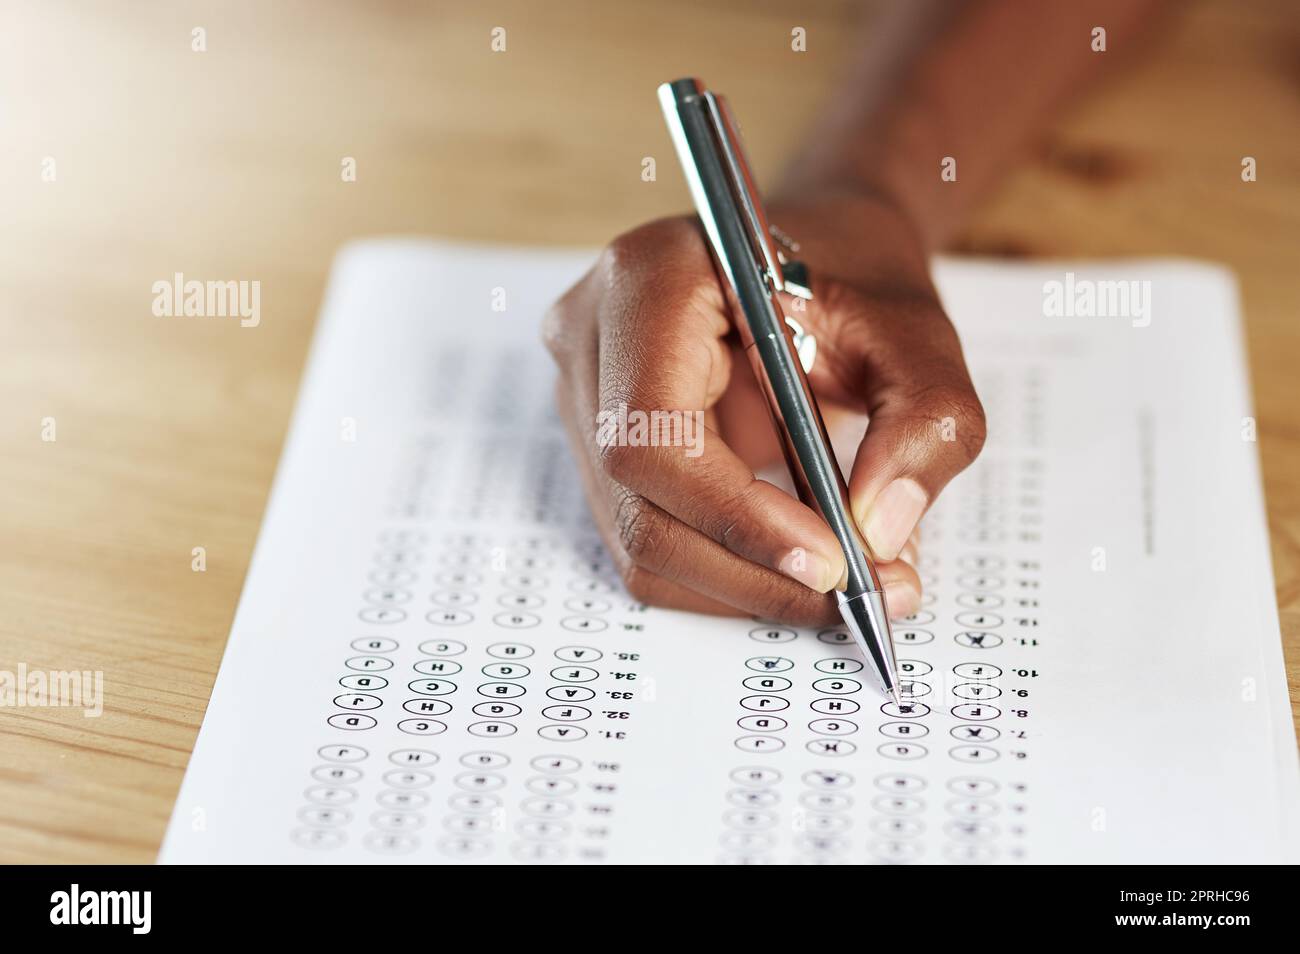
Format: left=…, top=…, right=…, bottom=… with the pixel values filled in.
left=659, top=78, right=900, bottom=702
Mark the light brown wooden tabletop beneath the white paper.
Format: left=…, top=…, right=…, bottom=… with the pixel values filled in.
left=0, top=0, right=1300, bottom=862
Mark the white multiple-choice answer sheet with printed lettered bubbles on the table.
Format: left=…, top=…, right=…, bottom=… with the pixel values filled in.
left=160, top=240, right=1300, bottom=864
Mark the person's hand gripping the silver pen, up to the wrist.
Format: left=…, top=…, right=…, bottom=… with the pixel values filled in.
left=543, top=194, right=984, bottom=625
